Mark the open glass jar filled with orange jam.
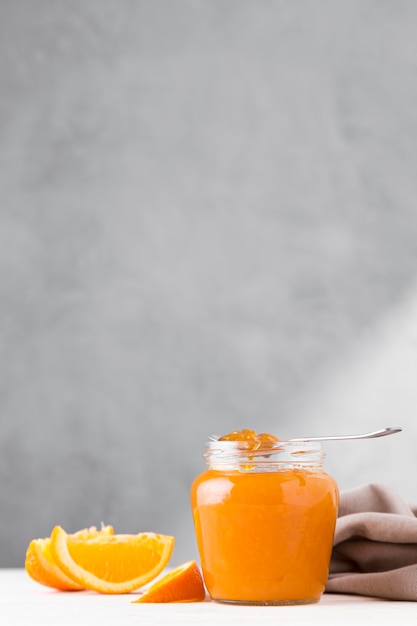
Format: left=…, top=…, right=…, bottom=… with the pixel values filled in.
left=191, top=430, right=338, bottom=604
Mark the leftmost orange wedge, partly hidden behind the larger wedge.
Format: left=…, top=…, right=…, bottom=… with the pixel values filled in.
left=25, top=526, right=113, bottom=591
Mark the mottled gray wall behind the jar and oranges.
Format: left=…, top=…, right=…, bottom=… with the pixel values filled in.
left=0, top=0, right=417, bottom=566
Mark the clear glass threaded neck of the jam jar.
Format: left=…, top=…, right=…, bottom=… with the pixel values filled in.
left=204, top=440, right=325, bottom=472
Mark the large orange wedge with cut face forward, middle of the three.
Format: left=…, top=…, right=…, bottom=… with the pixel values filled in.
left=51, top=526, right=174, bottom=593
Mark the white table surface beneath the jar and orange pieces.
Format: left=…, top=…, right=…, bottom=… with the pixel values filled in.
left=4, top=569, right=417, bottom=626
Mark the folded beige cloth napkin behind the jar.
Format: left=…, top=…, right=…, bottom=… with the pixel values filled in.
left=326, top=484, right=417, bottom=601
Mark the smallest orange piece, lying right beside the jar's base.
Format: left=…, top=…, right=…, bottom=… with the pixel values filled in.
left=133, top=561, right=206, bottom=604
